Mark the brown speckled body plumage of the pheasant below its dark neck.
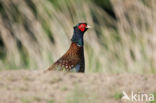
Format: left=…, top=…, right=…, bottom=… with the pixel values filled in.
left=48, top=43, right=85, bottom=72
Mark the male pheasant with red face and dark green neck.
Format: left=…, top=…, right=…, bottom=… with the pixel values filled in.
left=46, top=23, right=90, bottom=72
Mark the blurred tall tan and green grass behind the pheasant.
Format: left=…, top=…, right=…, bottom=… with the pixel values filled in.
left=0, top=0, right=156, bottom=73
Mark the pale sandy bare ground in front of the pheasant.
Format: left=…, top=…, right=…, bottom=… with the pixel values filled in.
left=0, top=70, right=156, bottom=103
